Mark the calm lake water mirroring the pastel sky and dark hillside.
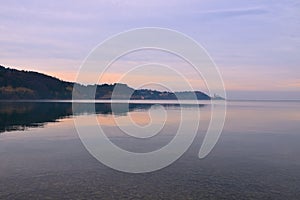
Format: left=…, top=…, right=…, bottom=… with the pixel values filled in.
left=0, top=101, right=300, bottom=199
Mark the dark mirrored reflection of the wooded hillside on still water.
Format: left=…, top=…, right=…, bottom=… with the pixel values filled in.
left=0, top=102, right=206, bottom=133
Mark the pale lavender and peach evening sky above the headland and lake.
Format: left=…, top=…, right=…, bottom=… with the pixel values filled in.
left=0, top=0, right=300, bottom=99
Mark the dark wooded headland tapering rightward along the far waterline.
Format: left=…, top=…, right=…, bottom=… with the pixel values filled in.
left=0, top=65, right=213, bottom=100
